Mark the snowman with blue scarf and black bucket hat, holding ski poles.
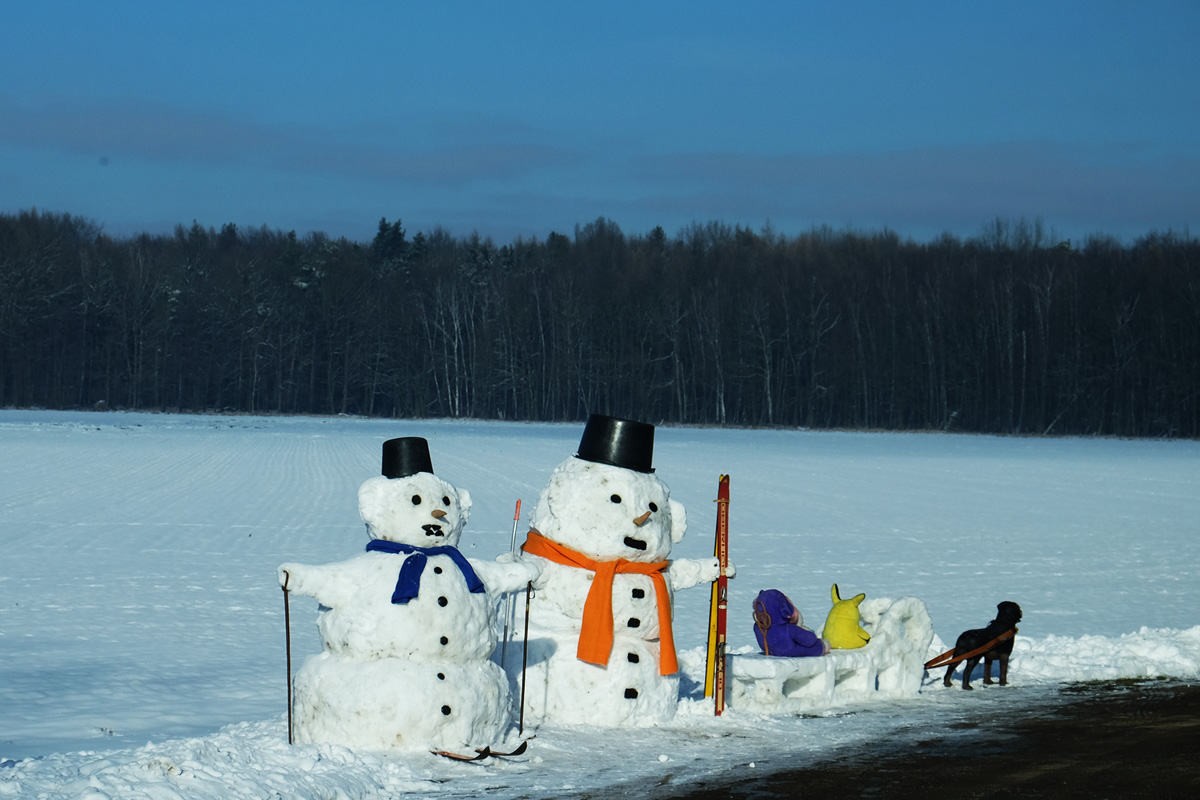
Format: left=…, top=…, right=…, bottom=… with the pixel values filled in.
left=278, top=437, right=538, bottom=751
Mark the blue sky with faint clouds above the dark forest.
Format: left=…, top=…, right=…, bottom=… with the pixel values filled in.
left=0, top=0, right=1200, bottom=243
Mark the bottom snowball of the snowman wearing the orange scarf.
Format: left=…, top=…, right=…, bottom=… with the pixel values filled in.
left=514, top=636, right=679, bottom=727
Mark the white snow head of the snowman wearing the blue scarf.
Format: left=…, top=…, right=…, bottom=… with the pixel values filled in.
left=359, top=473, right=470, bottom=547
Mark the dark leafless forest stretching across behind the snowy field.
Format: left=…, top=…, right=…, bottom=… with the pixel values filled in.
left=0, top=209, right=1200, bottom=438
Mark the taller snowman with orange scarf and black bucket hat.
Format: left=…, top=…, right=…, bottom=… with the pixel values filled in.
left=510, top=414, right=720, bottom=726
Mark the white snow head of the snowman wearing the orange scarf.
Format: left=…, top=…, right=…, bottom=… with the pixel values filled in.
left=532, top=458, right=688, bottom=561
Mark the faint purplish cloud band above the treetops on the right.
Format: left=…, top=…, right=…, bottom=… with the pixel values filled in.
left=631, top=142, right=1200, bottom=237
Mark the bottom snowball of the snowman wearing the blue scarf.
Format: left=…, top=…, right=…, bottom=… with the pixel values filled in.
left=293, top=652, right=511, bottom=752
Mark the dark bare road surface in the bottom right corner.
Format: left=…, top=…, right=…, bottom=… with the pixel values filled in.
left=676, top=680, right=1200, bottom=800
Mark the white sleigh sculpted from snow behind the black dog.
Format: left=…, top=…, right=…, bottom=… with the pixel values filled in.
left=727, top=597, right=934, bottom=714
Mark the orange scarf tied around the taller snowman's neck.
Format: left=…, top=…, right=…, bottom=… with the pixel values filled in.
left=521, top=530, right=679, bottom=675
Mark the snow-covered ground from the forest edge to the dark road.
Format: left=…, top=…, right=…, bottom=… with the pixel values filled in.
left=0, top=410, right=1200, bottom=799
